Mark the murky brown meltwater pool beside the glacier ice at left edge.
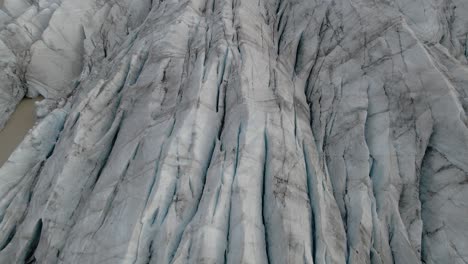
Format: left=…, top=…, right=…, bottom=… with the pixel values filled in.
left=0, top=97, right=43, bottom=167
